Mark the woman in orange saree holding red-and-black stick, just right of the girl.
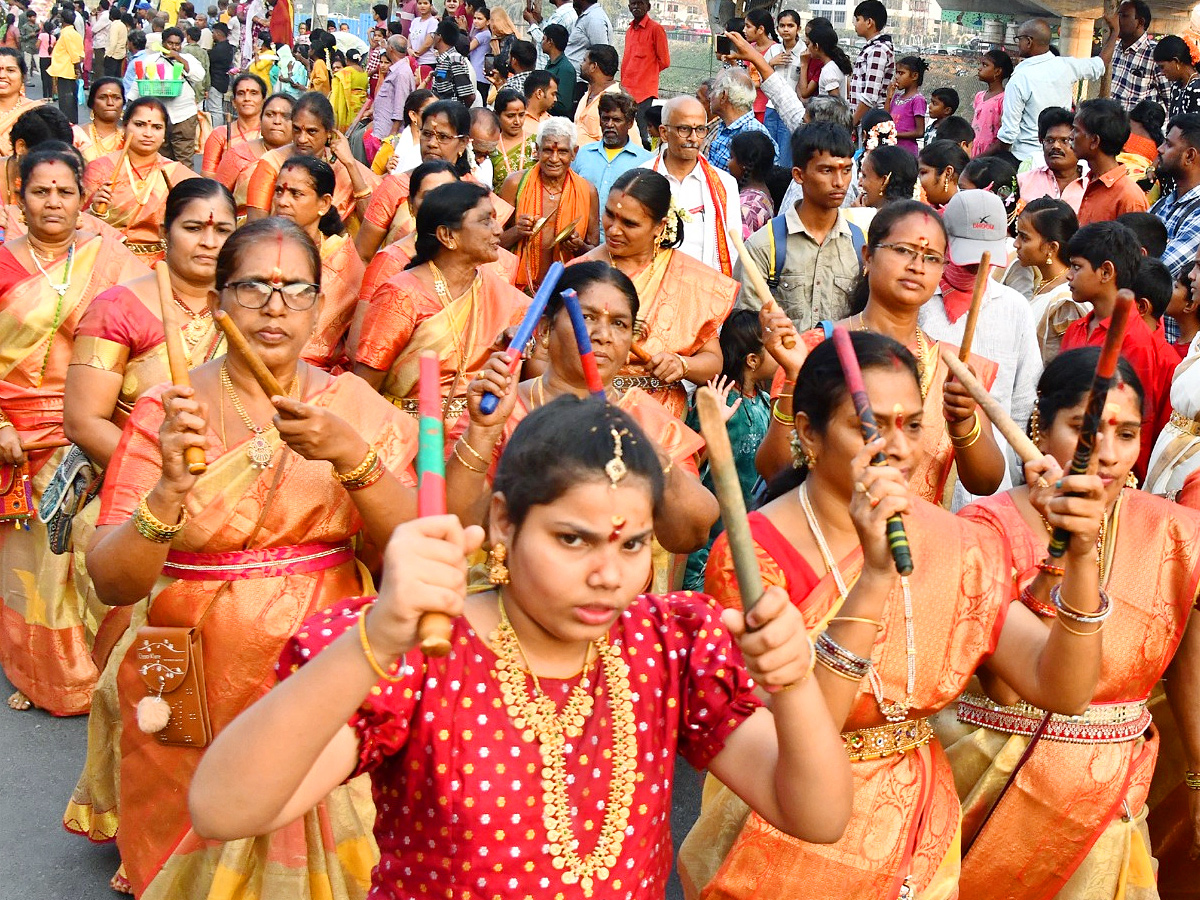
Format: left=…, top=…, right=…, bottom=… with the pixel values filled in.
left=679, top=331, right=1112, bottom=900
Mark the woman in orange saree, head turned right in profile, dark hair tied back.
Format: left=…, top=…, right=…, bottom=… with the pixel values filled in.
left=348, top=182, right=529, bottom=422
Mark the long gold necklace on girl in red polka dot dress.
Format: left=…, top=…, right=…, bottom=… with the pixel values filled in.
left=488, top=598, right=637, bottom=896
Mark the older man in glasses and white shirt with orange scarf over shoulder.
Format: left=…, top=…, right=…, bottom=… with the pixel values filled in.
left=641, top=96, right=742, bottom=277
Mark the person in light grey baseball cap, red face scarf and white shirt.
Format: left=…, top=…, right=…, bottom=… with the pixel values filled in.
left=918, top=191, right=1042, bottom=510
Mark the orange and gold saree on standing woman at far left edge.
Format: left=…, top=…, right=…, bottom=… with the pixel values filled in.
left=0, top=236, right=146, bottom=715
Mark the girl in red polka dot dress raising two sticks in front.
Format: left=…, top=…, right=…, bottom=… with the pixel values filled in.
left=191, top=397, right=851, bottom=900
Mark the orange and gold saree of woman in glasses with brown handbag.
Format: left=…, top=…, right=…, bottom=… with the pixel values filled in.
left=101, top=374, right=416, bottom=900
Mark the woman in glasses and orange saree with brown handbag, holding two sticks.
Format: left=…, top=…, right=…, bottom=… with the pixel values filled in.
left=88, top=218, right=416, bottom=900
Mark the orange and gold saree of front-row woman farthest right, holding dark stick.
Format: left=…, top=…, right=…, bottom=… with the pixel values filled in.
left=946, top=490, right=1200, bottom=900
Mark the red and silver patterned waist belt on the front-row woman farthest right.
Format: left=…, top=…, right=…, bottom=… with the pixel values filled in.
left=959, top=694, right=1151, bottom=744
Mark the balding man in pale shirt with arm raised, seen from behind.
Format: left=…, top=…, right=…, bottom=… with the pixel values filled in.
left=989, top=16, right=1117, bottom=166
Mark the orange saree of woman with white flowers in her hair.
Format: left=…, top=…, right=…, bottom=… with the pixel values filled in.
left=609, top=250, right=740, bottom=419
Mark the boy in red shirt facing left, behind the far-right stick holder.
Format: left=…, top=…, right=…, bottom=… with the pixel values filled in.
left=1062, top=222, right=1174, bottom=479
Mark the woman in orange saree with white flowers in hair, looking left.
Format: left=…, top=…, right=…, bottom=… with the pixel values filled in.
left=571, top=169, right=738, bottom=419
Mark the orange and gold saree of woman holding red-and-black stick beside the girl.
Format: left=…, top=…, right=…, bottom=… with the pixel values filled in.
left=694, top=500, right=1013, bottom=900
